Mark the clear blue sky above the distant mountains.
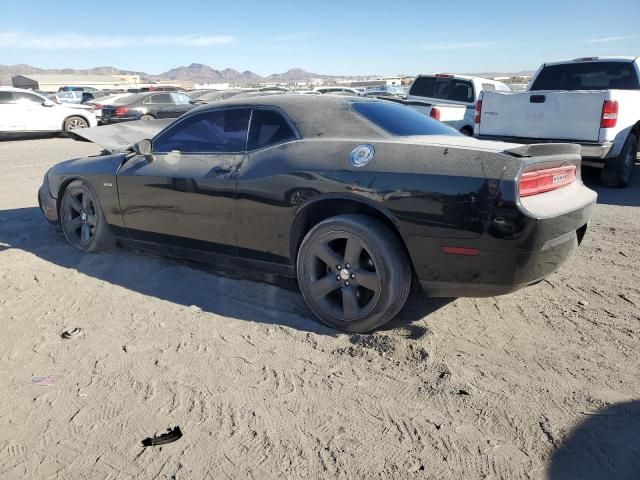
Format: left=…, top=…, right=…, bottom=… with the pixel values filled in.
left=0, top=0, right=640, bottom=75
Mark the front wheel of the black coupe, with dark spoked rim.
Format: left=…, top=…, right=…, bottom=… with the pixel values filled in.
left=60, top=180, right=116, bottom=253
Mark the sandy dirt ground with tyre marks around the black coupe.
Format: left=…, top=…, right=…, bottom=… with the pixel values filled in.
left=0, top=138, right=640, bottom=480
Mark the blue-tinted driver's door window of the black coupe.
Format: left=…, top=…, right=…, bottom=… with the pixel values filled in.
left=153, top=108, right=251, bottom=153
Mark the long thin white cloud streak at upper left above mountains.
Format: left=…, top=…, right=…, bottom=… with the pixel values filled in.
left=0, top=32, right=234, bottom=50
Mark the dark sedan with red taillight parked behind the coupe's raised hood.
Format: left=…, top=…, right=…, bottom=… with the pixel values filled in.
left=102, top=92, right=196, bottom=124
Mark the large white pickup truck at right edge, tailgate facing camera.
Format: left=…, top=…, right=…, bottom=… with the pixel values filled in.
left=474, top=57, right=640, bottom=187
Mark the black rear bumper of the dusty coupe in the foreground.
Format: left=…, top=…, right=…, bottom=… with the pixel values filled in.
left=409, top=185, right=596, bottom=297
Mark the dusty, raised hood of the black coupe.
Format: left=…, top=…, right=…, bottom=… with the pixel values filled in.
left=68, top=118, right=175, bottom=153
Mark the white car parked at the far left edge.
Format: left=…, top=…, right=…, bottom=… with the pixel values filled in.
left=0, top=87, right=97, bottom=133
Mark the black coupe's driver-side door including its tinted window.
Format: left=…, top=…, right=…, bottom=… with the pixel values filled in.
left=117, top=107, right=251, bottom=255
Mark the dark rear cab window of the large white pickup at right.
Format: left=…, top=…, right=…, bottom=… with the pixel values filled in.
left=531, top=62, right=640, bottom=91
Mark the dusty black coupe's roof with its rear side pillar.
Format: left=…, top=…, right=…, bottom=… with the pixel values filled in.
left=190, top=94, right=389, bottom=139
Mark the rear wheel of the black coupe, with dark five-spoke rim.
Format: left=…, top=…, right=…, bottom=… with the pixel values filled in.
left=297, top=215, right=411, bottom=333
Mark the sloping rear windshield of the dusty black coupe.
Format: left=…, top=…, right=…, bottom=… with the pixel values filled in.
left=351, top=101, right=461, bottom=137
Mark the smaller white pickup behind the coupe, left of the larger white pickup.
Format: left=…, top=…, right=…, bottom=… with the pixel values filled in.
left=407, top=73, right=510, bottom=136
